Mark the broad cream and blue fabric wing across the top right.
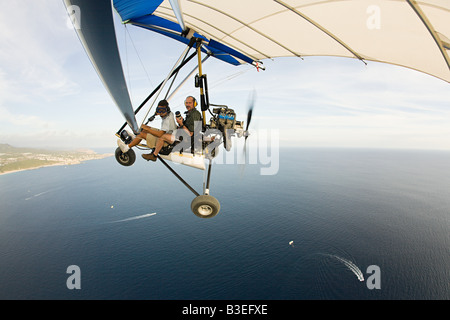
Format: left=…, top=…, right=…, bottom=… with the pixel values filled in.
left=113, top=0, right=450, bottom=82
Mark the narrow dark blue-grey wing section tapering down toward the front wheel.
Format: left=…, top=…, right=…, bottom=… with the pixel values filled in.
left=64, top=0, right=139, bottom=132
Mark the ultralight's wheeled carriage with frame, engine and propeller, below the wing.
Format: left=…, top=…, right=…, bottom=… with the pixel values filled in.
left=115, top=37, right=253, bottom=218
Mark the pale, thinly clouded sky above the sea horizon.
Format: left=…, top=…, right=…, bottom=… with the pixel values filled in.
left=0, top=0, right=450, bottom=150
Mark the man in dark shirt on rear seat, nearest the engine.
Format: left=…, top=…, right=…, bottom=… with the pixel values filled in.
left=142, top=96, right=202, bottom=161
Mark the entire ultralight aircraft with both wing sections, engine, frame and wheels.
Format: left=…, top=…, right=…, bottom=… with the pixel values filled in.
left=63, top=0, right=450, bottom=218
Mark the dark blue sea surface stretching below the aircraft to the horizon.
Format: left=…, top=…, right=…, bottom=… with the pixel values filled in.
left=0, top=148, right=450, bottom=300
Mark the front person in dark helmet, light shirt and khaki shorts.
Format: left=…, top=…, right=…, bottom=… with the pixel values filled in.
left=117, top=100, right=177, bottom=161
